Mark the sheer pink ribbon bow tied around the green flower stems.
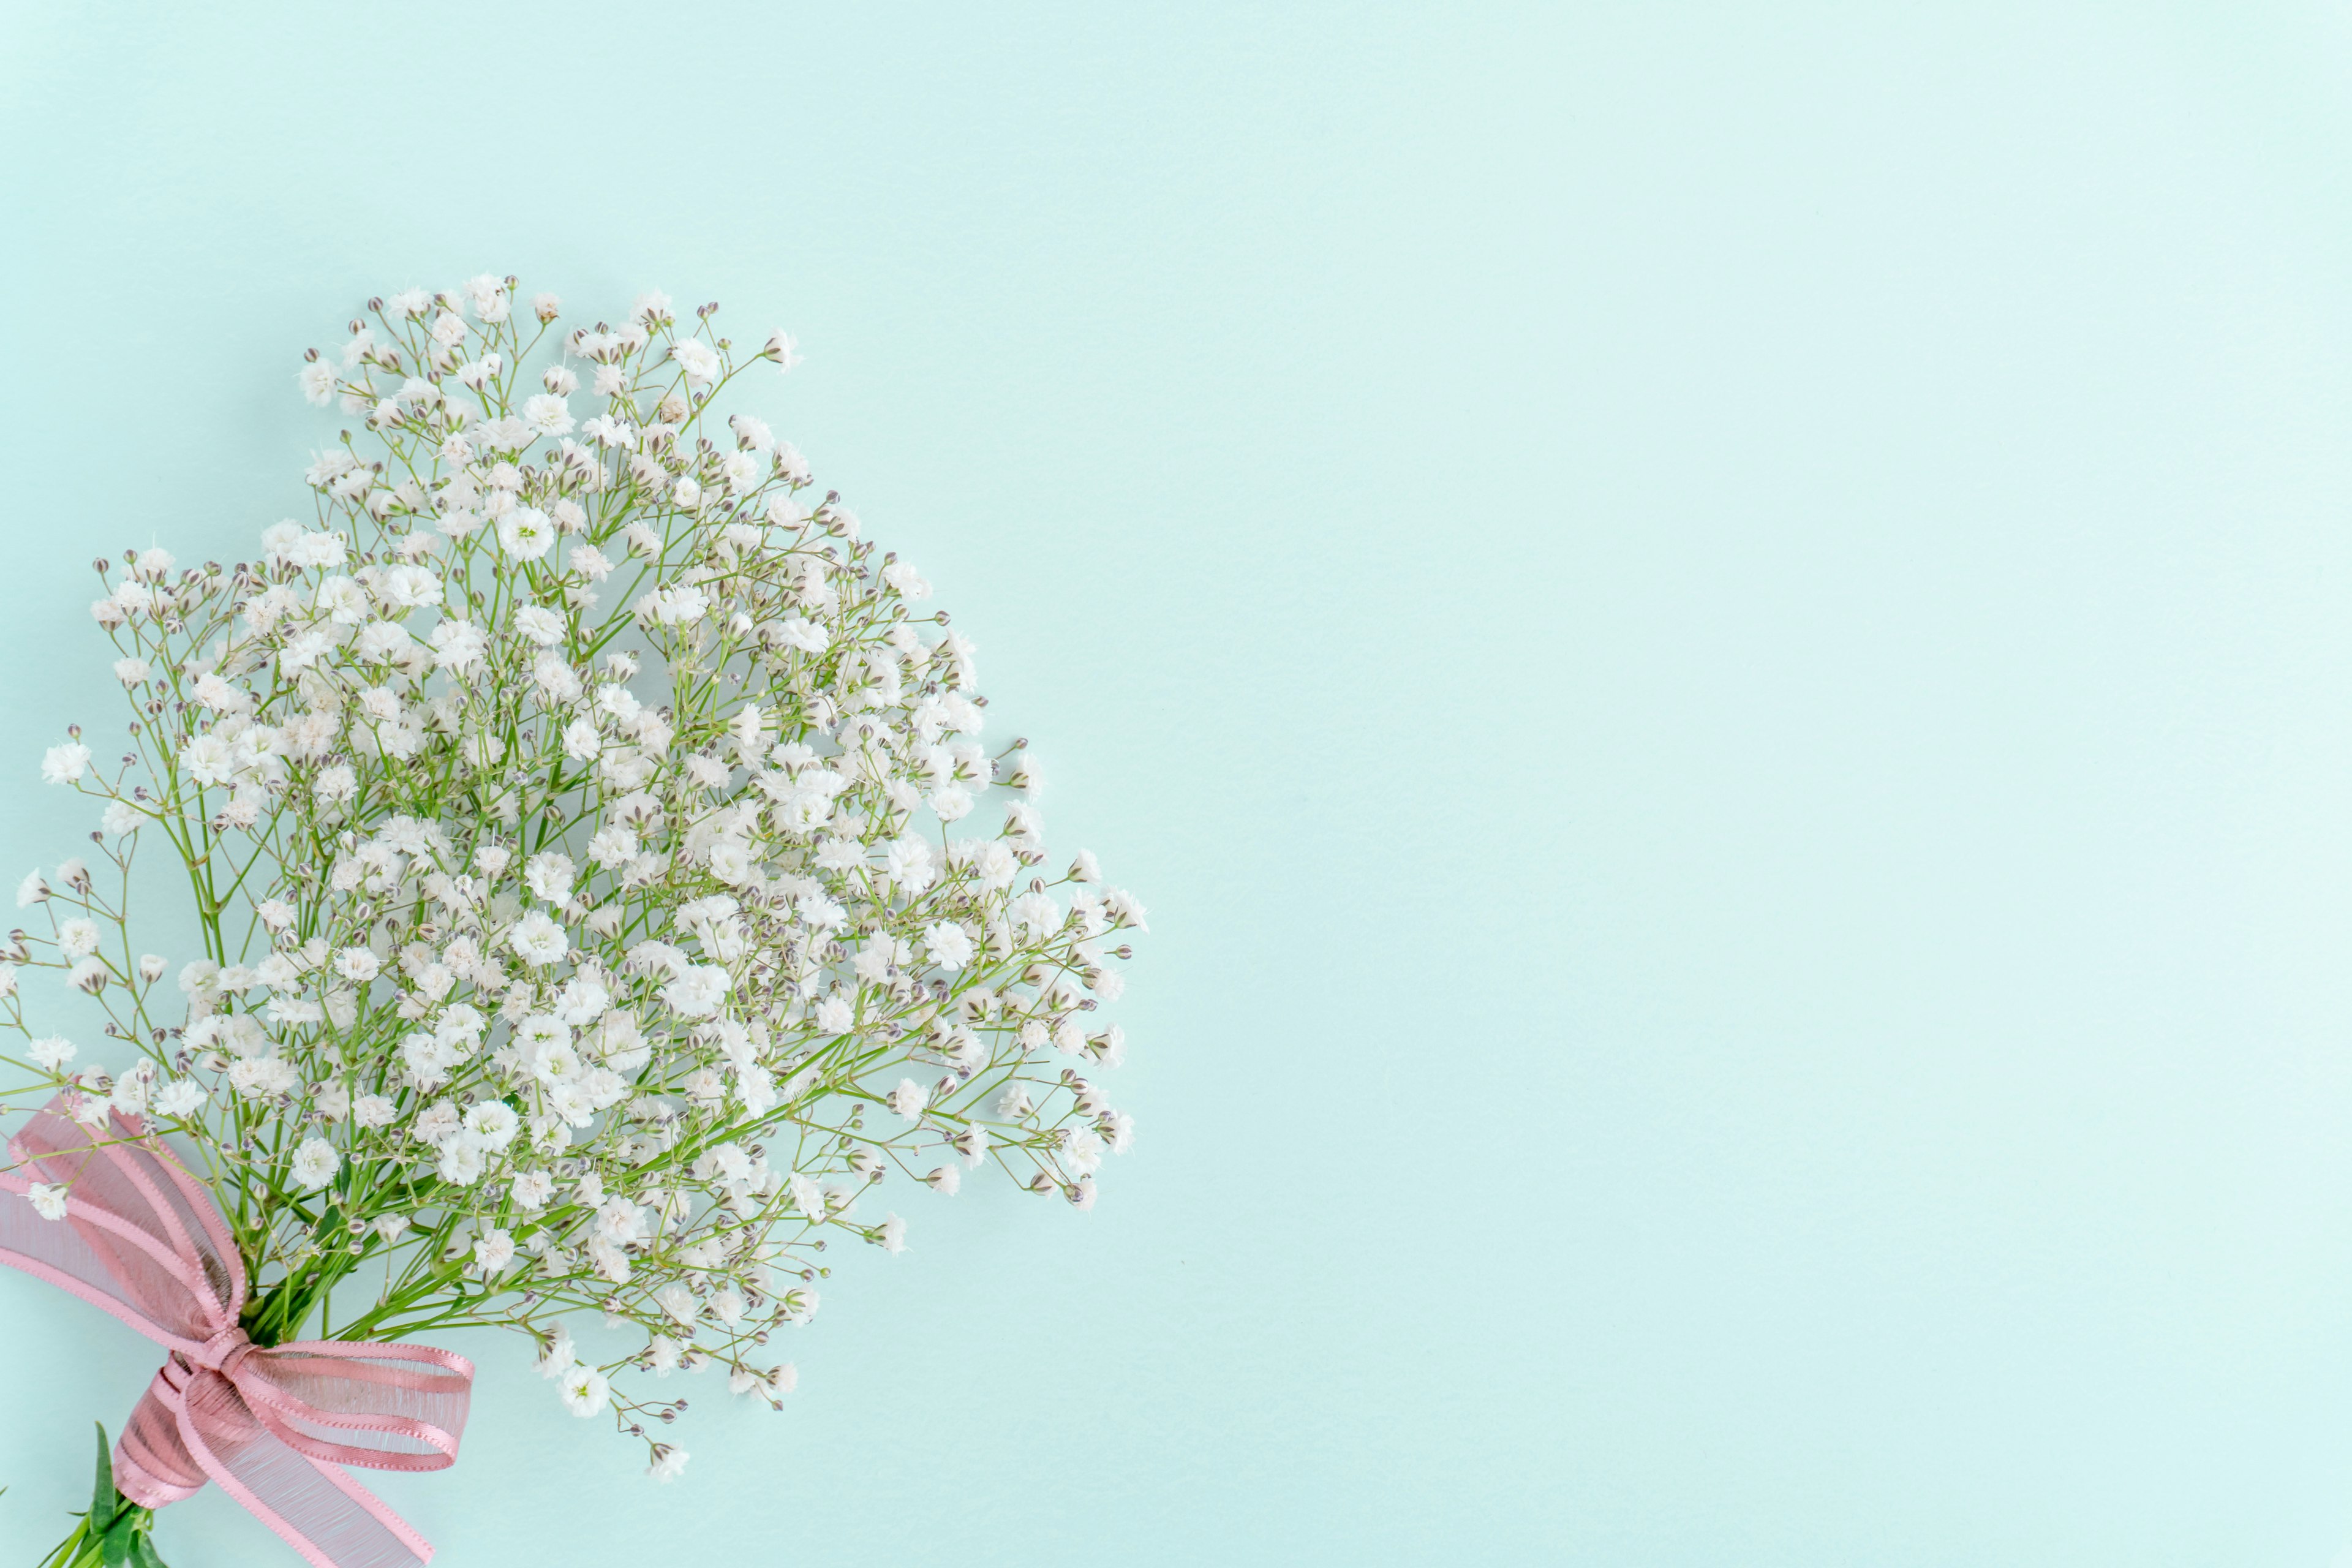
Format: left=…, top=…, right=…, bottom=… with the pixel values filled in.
left=0, top=1096, right=473, bottom=1568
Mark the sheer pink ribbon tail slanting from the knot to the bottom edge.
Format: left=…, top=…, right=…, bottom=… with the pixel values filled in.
left=176, top=1373, right=433, bottom=1568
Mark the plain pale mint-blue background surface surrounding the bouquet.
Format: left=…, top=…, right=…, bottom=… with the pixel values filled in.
left=0, top=0, right=2352, bottom=1568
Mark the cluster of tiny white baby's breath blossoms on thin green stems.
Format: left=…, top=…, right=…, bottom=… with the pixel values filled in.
left=0, top=277, right=1143, bottom=1479
